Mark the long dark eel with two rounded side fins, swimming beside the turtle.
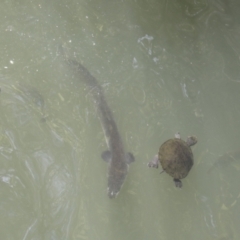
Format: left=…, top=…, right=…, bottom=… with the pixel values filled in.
left=64, top=59, right=134, bottom=198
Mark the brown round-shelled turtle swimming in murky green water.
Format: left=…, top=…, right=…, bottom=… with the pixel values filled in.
left=148, top=133, right=197, bottom=188
